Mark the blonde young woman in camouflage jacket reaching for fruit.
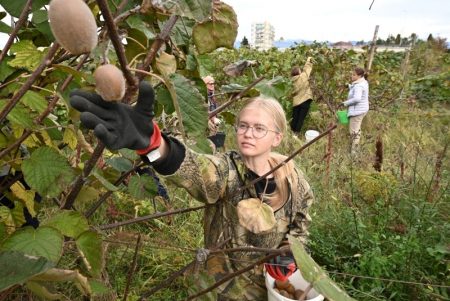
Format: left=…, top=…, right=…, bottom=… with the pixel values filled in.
left=70, top=82, right=313, bottom=300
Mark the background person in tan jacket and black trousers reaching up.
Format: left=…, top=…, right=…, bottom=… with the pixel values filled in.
left=291, top=57, right=313, bottom=135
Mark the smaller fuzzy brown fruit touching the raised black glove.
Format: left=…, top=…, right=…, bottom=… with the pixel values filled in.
left=94, top=64, right=125, bottom=101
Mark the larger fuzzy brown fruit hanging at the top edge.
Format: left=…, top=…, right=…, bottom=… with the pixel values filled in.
left=48, top=0, right=97, bottom=55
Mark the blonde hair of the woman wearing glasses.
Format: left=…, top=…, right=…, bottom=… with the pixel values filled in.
left=238, top=96, right=298, bottom=202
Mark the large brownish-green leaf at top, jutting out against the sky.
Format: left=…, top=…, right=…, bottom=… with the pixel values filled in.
left=192, top=1, right=238, bottom=54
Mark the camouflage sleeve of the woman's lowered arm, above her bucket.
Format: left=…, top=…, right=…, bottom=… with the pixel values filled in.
left=289, top=166, right=314, bottom=243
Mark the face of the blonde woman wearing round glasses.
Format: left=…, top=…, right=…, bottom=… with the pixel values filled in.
left=237, top=105, right=283, bottom=158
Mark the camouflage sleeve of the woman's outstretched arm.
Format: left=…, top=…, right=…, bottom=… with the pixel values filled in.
left=158, top=142, right=229, bottom=204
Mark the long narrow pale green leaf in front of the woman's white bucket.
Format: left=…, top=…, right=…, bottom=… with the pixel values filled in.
left=288, top=235, right=355, bottom=301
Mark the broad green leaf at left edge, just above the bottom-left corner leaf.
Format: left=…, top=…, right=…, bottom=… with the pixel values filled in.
left=2, top=226, right=64, bottom=263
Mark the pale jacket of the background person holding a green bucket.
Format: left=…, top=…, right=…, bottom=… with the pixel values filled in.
left=344, top=78, right=369, bottom=117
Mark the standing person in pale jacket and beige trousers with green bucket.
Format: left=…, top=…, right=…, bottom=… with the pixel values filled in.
left=342, top=67, right=369, bottom=153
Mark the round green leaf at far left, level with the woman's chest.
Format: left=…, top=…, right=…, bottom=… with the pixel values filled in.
left=22, top=146, right=74, bottom=197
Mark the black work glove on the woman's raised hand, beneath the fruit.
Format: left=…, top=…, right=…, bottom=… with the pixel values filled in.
left=70, top=81, right=156, bottom=150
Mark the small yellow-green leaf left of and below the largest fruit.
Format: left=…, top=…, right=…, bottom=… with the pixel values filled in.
left=8, top=40, right=45, bottom=71
